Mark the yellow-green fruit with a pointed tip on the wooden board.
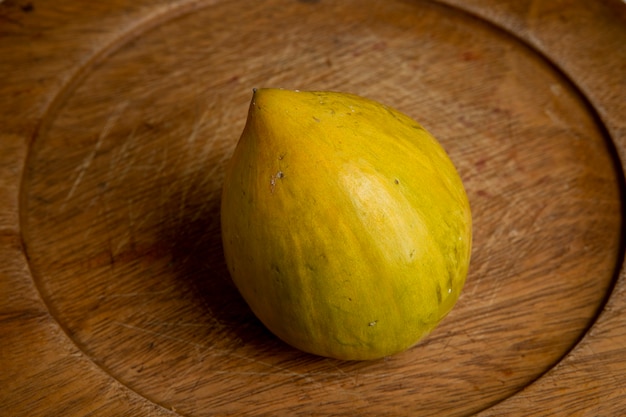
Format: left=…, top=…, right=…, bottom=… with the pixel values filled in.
left=221, top=89, right=472, bottom=360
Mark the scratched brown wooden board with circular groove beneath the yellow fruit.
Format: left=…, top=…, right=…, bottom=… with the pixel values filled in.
left=0, top=0, right=626, bottom=416
